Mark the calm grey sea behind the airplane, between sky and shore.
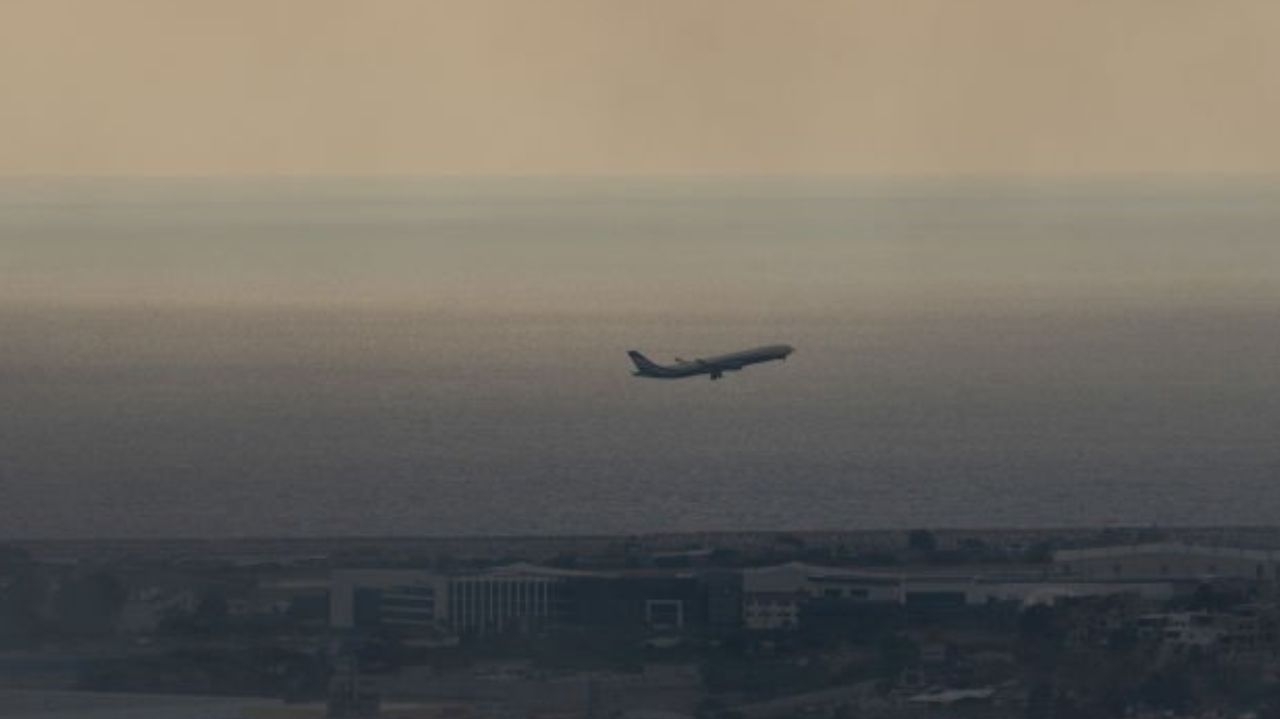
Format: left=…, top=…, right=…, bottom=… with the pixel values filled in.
left=0, top=180, right=1280, bottom=537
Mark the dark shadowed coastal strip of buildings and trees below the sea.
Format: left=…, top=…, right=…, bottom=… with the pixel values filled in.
left=0, top=528, right=1280, bottom=719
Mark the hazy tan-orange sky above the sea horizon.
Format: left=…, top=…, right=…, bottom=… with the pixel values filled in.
left=0, top=0, right=1280, bottom=174
